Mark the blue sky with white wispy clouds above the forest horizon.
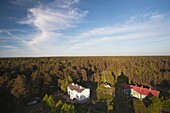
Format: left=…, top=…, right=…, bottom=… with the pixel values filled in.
left=0, top=0, right=170, bottom=57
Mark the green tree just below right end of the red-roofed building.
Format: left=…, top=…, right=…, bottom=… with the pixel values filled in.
left=148, top=97, right=162, bottom=113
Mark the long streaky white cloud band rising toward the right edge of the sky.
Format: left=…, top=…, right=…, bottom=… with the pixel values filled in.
left=70, top=12, right=170, bottom=51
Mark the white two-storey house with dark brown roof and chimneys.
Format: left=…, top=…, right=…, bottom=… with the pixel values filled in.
left=67, top=83, right=90, bottom=101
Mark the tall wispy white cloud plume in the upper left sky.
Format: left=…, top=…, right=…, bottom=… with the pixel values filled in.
left=18, top=0, right=88, bottom=46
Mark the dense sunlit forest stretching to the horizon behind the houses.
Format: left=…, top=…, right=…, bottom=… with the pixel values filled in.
left=0, top=56, right=170, bottom=113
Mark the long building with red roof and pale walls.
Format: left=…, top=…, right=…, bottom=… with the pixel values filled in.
left=122, top=84, right=159, bottom=99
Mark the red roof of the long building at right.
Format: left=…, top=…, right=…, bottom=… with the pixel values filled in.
left=122, top=84, right=159, bottom=96
